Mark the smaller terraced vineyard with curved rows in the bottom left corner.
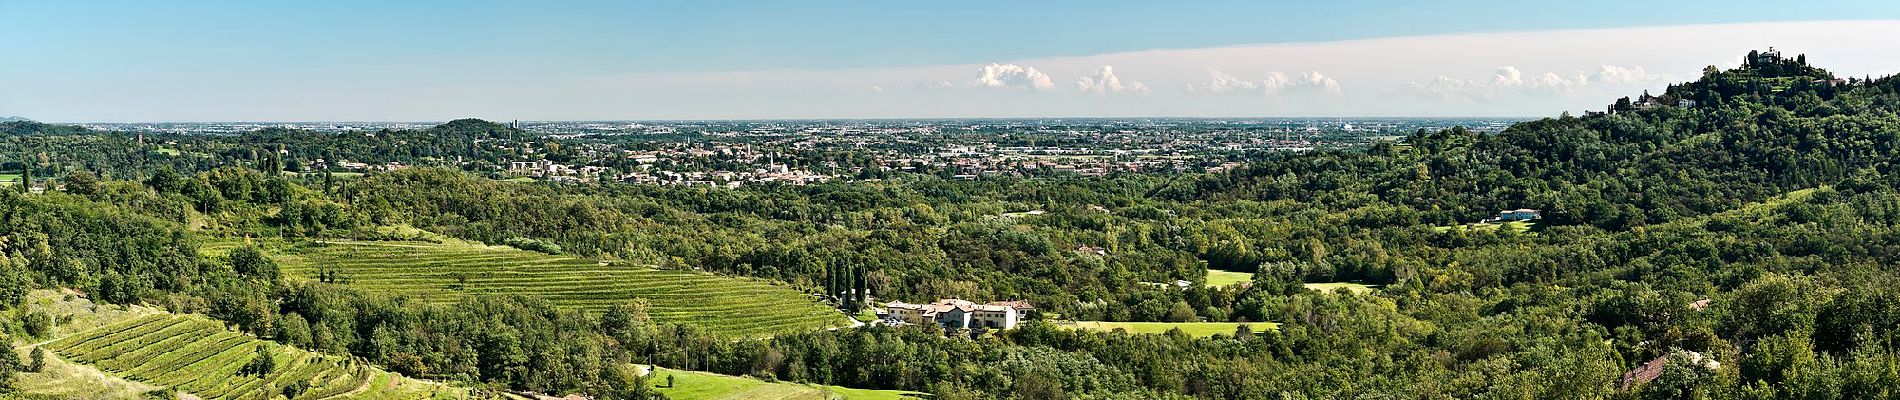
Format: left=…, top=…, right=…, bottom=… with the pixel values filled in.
left=44, top=313, right=466, bottom=400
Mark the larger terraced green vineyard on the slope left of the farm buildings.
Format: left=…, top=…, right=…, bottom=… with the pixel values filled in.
left=274, top=241, right=849, bottom=337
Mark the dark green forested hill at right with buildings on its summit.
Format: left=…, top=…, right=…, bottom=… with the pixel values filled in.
left=1172, top=53, right=1900, bottom=229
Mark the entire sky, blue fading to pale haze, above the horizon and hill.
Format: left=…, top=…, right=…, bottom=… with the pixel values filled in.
left=11, top=0, right=1900, bottom=121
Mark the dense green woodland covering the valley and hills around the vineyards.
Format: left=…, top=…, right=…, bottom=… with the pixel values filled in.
left=0, top=51, right=1900, bottom=398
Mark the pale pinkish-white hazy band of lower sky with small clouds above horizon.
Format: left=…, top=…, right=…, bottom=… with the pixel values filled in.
left=11, top=21, right=1900, bottom=121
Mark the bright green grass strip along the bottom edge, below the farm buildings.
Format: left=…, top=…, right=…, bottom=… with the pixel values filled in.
left=648, top=368, right=922, bottom=400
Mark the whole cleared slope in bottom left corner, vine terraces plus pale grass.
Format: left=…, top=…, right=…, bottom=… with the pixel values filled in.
left=21, top=290, right=466, bottom=400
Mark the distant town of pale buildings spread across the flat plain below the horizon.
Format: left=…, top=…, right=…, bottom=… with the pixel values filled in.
left=87, top=118, right=1512, bottom=188
